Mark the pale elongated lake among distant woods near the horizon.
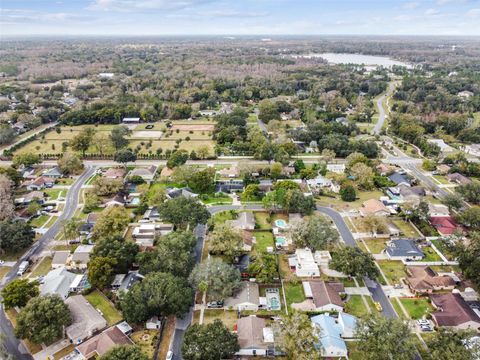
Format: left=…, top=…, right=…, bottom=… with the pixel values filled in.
left=298, top=53, right=411, bottom=68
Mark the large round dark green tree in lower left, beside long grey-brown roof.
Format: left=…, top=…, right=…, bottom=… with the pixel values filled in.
left=15, top=295, right=72, bottom=344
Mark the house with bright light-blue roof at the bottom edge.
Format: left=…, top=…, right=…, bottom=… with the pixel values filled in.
left=310, top=313, right=357, bottom=358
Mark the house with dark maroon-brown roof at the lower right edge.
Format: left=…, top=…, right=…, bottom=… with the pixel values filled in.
left=430, top=293, right=480, bottom=331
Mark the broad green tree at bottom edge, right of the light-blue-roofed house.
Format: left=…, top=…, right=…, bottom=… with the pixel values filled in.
left=355, top=315, right=416, bottom=360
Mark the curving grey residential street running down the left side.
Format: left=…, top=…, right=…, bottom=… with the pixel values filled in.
left=0, top=167, right=95, bottom=360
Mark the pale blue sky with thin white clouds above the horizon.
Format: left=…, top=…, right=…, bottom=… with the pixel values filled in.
left=0, top=0, right=480, bottom=37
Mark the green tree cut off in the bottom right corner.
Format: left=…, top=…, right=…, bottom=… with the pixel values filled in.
left=427, top=328, right=480, bottom=360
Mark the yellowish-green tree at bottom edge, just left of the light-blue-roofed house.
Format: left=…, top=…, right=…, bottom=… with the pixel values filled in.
left=276, top=311, right=321, bottom=360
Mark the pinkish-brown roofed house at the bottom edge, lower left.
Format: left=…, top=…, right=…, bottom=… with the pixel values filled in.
left=75, top=326, right=133, bottom=360
